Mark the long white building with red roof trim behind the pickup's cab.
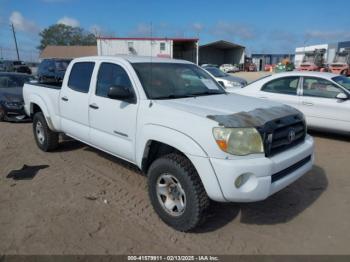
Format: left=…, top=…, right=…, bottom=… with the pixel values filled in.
left=97, top=37, right=198, bottom=64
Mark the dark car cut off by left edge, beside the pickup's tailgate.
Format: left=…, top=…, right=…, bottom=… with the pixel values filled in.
left=0, top=72, right=33, bottom=122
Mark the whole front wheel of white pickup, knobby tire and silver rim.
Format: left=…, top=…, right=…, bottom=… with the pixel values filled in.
left=148, top=154, right=209, bottom=231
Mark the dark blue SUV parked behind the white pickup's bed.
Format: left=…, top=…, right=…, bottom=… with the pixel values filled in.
left=37, top=58, right=71, bottom=83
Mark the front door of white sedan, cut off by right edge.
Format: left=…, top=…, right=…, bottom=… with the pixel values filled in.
left=301, top=77, right=350, bottom=131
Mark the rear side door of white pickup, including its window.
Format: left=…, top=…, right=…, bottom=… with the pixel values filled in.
left=60, top=62, right=95, bottom=143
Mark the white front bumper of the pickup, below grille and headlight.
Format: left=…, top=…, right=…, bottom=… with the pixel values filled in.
left=210, top=135, right=314, bottom=202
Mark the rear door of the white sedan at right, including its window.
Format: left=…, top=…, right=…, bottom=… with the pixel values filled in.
left=258, top=76, right=300, bottom=108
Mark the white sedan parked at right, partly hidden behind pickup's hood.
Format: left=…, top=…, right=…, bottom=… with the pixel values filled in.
left=232, top=71, right=350, bottom=134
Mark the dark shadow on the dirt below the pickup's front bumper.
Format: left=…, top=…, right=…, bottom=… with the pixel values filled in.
left=196, top=166, right=328, bottom=233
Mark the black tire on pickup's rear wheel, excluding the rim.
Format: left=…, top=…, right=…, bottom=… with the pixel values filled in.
left=33, top=112, right=59, bottom=152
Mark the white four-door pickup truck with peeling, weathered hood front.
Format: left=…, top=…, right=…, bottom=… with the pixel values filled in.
left=23, top=56, right=314, bottom=231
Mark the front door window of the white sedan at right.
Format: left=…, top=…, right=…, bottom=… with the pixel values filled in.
left=303, top=77, right=342, bottom=98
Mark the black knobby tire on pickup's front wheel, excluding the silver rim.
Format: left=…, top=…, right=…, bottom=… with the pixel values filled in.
left=147, top=153, right=210, bottom=232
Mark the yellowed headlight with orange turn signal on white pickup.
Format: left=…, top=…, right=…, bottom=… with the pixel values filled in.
left=213, top=127, right=264, bottom=156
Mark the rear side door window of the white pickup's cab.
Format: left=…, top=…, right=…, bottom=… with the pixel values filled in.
left=68, top=62, right=95, bottom=93
